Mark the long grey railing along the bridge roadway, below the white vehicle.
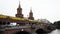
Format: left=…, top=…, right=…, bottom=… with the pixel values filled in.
left=0, top=24, right=43, bottom=29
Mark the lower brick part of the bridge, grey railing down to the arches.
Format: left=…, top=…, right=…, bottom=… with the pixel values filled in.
left=0, top=25, right=46, bottom=34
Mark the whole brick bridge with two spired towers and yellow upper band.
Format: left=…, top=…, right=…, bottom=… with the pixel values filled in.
left=0, top=3, right=52, bottom=34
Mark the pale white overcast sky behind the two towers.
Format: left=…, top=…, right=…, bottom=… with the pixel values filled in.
left=0, top=0, right=60, bottom=23
